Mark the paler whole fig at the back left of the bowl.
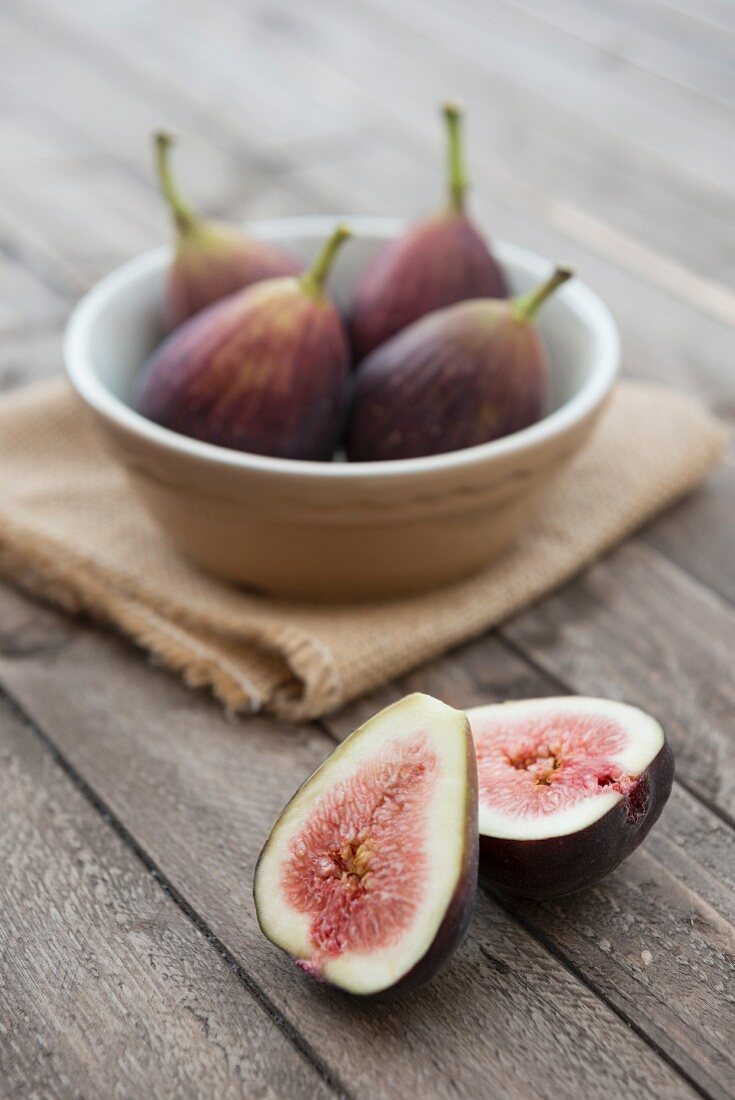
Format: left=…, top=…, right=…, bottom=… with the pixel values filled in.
left=155, top=133, right=304, bottom=329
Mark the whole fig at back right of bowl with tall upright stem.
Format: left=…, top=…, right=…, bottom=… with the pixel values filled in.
left=350, top=103, right=507, bottom=360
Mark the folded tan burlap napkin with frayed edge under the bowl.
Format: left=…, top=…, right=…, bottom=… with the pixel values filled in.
left=0, top=380, right=726, bottom=718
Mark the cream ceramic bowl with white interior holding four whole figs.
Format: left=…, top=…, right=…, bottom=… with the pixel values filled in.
left=65, top=217, right=619, bottom=600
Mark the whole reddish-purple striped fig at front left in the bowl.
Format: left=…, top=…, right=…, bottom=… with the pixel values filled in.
left=136, top=226, right=350, bottom=460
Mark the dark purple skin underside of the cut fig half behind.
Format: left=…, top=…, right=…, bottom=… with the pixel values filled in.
left=480, top=741, right=674, bottom=901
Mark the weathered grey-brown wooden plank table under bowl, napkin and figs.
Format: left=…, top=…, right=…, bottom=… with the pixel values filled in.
left=0, top=0, right=735, bottom=1100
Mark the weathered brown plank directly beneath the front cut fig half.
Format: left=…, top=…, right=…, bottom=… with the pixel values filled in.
left=0, top=594, right=694, bottom=1100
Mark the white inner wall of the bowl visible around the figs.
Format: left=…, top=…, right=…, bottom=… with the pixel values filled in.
left=76, top=217, right=614, bottom=448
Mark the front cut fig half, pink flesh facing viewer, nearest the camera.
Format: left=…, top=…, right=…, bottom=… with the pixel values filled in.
left=253, top=694, right=478, bottom=997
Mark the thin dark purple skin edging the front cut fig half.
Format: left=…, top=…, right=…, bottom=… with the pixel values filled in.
left=253, top=694, right=480, bottom=1002
